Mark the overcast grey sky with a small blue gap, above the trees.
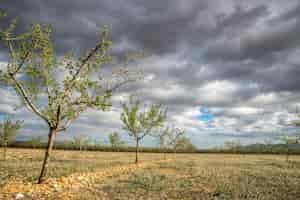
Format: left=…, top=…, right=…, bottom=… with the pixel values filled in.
left=0, top=0, right=300, bottom=148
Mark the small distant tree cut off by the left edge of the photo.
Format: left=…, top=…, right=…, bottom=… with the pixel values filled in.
left=0, top=119, right=22, bottom=161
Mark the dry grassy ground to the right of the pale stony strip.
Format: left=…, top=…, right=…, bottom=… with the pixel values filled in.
left=77, top=154, right=300, bottom=200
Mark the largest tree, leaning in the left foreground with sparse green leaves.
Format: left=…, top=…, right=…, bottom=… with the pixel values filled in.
left=0, top=14, right=136, bottom=183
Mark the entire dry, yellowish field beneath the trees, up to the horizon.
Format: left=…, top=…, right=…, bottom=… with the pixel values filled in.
left=0, top=149, right=300, bottom=200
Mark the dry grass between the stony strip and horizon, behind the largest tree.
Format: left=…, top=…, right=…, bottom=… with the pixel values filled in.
left=0, top=149, right=163, bottom=187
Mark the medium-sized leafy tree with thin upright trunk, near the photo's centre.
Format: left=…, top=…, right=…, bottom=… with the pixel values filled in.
left=121, top=97, right=166, bottom=164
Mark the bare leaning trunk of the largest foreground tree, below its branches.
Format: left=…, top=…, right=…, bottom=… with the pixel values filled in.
left=38, top=128, right=56, bottom=184
